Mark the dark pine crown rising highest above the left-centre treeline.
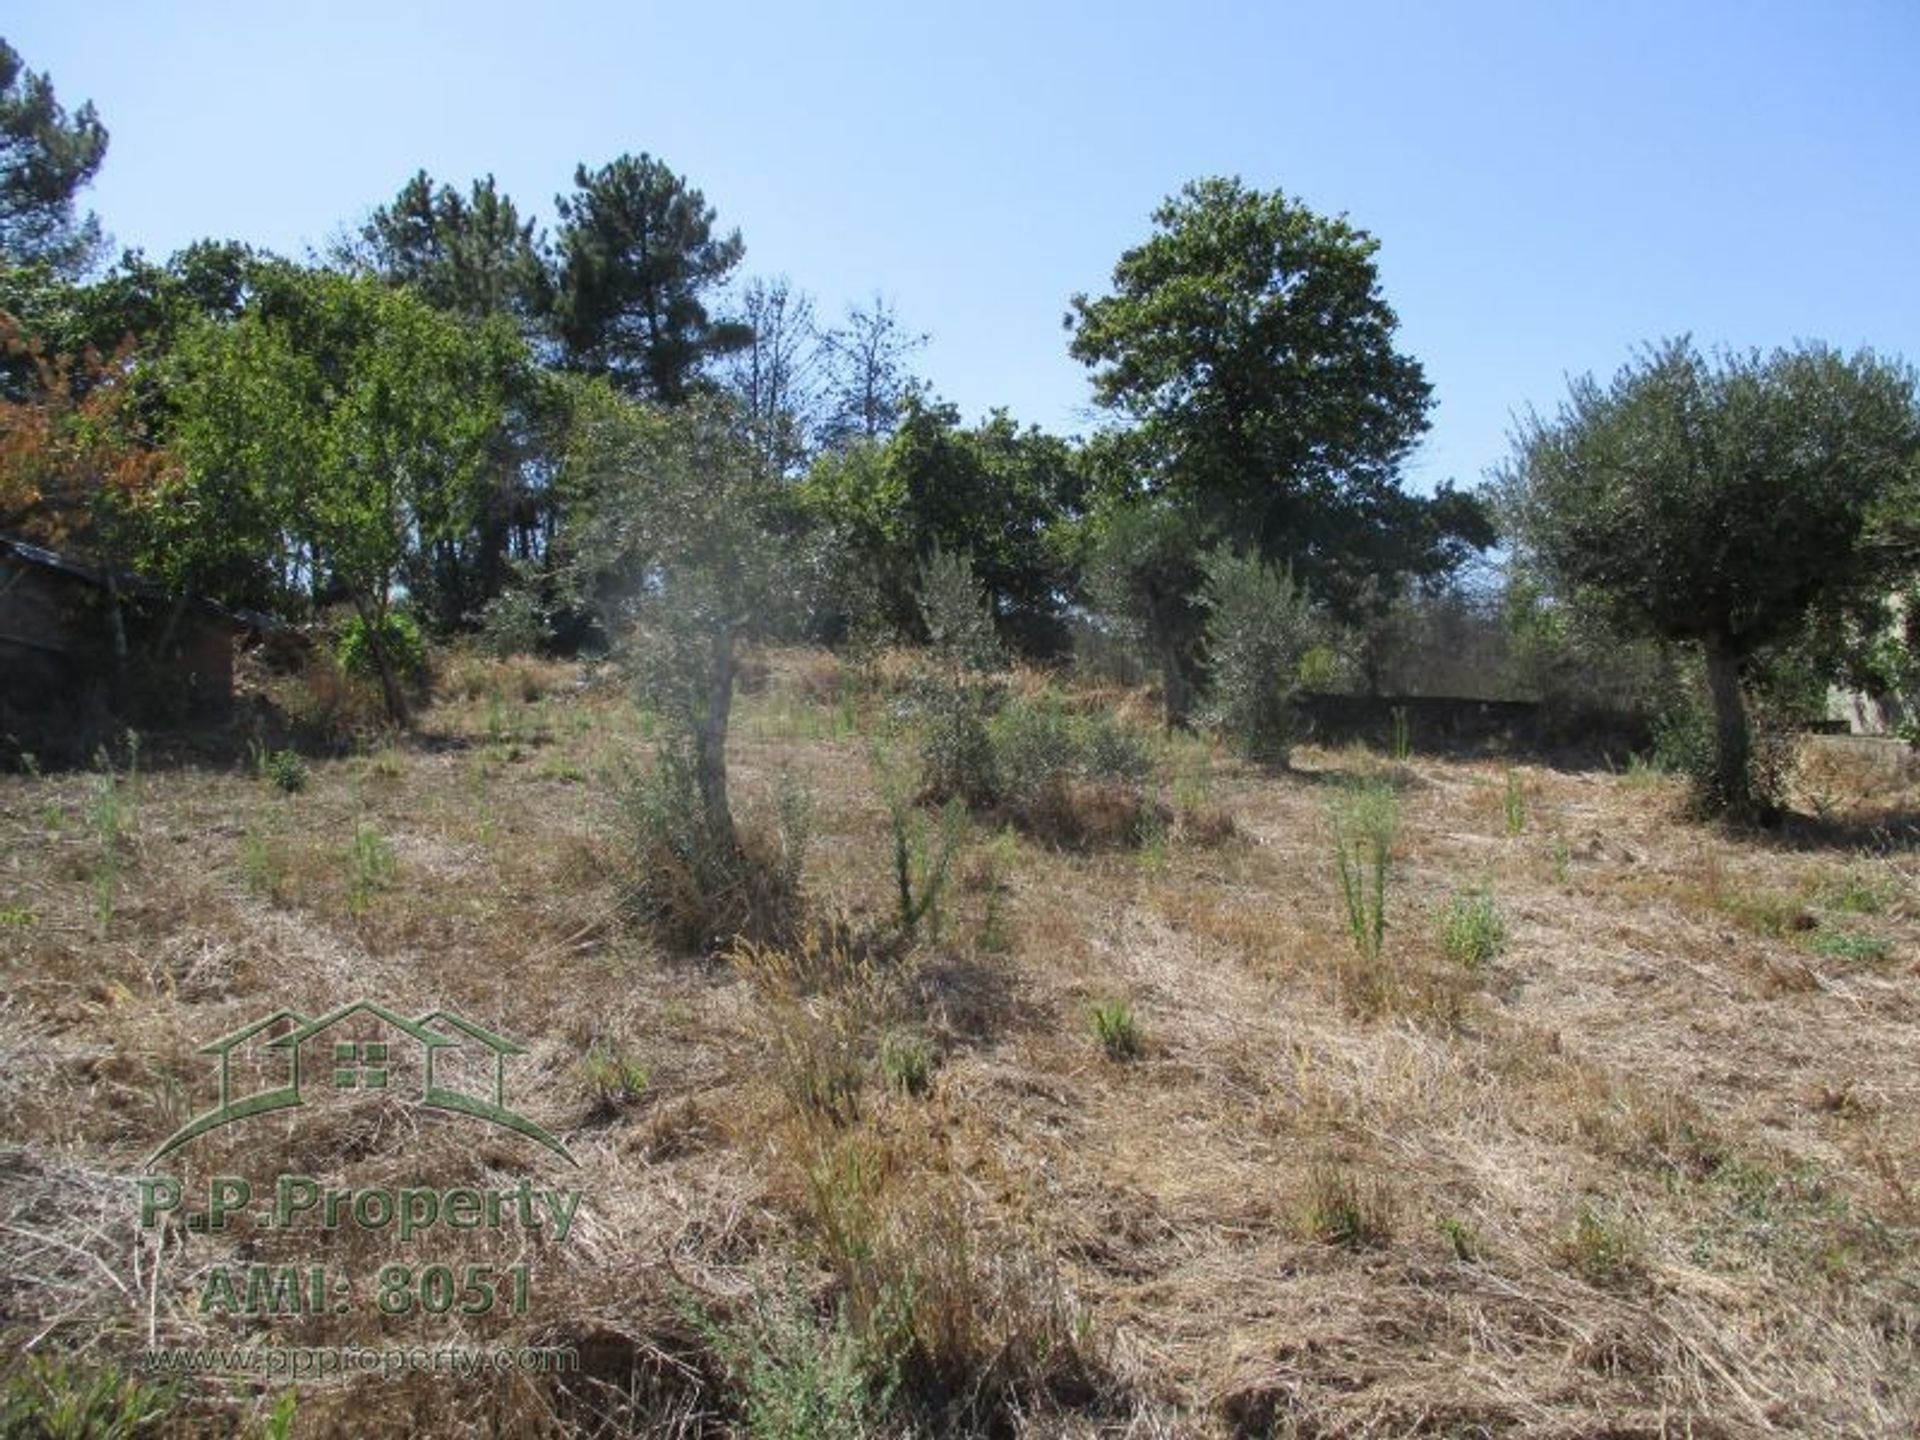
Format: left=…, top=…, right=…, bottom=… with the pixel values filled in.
left=555, top=154, right=751, bottom=405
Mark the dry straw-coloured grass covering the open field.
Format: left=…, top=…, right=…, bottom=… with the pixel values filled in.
left=0, top=655, right=1920, bottom=1436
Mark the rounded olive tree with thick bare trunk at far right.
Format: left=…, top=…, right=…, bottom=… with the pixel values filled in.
left=1496, top=340, right=1920, bottom=816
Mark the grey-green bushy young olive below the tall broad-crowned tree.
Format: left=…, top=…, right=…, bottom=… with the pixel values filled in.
left=1200, top=547, right=1313, bottom=764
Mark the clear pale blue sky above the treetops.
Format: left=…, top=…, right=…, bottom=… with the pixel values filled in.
left=0, top=0, right=1920, bottom=488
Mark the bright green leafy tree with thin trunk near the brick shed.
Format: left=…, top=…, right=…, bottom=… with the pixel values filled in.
left=161, top=267, right=524, bottom=720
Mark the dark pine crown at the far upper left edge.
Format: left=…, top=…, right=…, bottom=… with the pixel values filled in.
left=0, top=40, right=108, bottom=276
